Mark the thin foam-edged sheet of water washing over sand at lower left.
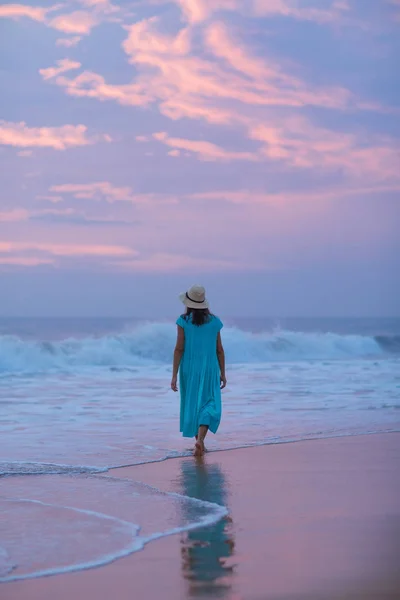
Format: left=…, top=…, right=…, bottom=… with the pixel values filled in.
left=0, top=477, right=228, bottom=583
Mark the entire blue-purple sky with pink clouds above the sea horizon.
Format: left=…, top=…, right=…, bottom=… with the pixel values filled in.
left=0, top=0, right=400, bottom=318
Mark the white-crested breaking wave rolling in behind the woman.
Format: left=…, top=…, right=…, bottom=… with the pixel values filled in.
left=0, top=323, right=400, bottom=373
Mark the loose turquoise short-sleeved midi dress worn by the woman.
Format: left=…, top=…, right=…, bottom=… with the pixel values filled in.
left=176, top=315, right=223, bottom=437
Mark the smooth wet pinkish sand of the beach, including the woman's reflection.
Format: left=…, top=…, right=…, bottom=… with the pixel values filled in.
left=0, top=433, right=400, bottom=600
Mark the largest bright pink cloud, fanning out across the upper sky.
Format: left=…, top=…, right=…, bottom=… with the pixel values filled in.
left=43, top=18, right=353, bottom=125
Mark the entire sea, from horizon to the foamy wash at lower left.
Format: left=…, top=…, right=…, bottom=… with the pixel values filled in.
left=0, top=315, right=400, bottom=582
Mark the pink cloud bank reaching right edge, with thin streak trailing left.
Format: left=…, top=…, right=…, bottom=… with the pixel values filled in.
left=149, top=116, right=399, bottom=176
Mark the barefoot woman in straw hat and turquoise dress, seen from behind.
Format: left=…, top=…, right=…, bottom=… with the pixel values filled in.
left=171, top=285, right=226, bottom=456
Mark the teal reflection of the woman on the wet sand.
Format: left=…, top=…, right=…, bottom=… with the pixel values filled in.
left=180, top=459, right=234, bottom=598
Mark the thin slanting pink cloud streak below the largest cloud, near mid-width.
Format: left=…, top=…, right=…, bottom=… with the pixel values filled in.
left=153, top=132, right=258, bottom=162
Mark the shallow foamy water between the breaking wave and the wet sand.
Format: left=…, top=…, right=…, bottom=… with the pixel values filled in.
left=0, top=358, right=400, bottom=473
